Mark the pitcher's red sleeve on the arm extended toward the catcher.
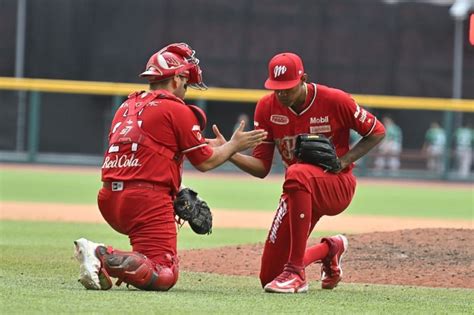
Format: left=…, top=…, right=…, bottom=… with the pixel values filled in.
left=252, top=96, right=275, bottom=172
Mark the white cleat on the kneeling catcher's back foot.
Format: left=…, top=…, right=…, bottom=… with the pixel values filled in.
left=74, top=238, right=112, bottom=290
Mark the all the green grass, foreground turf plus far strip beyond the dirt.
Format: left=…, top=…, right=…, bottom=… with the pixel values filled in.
left=0, top=170, right=474, bottom=314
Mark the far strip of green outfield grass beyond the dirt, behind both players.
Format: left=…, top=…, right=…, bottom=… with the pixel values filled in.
left=0, top=170, right=474, bottom=219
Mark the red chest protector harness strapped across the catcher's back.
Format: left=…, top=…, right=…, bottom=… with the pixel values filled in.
left=109, top=92, right=182, bottom=161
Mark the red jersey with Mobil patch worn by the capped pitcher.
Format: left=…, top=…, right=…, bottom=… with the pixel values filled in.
left=253, top=83, right=384, bottom=172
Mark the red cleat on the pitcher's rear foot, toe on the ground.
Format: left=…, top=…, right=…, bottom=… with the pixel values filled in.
left=321, top=234, right=349, bottom=289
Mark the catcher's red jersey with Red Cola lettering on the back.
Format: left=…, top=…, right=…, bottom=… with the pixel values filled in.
left=102, top=90, right=213, bottom=192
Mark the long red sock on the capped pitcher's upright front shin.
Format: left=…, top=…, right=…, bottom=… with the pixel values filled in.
left=287, top=190, right=312, bottom=267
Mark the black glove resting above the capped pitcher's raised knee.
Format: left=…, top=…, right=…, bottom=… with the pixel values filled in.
left=295, top=134, right=341, bottom=173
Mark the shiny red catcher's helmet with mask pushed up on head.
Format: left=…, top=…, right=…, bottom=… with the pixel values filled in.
left=140, top=43, right=207, bottom=90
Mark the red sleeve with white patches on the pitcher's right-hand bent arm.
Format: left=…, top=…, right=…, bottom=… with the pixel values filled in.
left=336, top=90, right=385, bottom=137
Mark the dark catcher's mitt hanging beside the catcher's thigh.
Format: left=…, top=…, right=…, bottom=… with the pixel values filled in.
left=173, top=188, right=212, bottom=234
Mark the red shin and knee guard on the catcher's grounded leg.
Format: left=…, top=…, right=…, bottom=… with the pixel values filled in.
left=97, top=246, right=178, bottom=291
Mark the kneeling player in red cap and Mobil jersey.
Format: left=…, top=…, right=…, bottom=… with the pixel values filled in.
left=213, top=53, right=385, bottom=293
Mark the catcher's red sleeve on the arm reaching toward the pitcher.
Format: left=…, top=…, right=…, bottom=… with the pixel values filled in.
left=174, top=106, right=213, bottom=165
